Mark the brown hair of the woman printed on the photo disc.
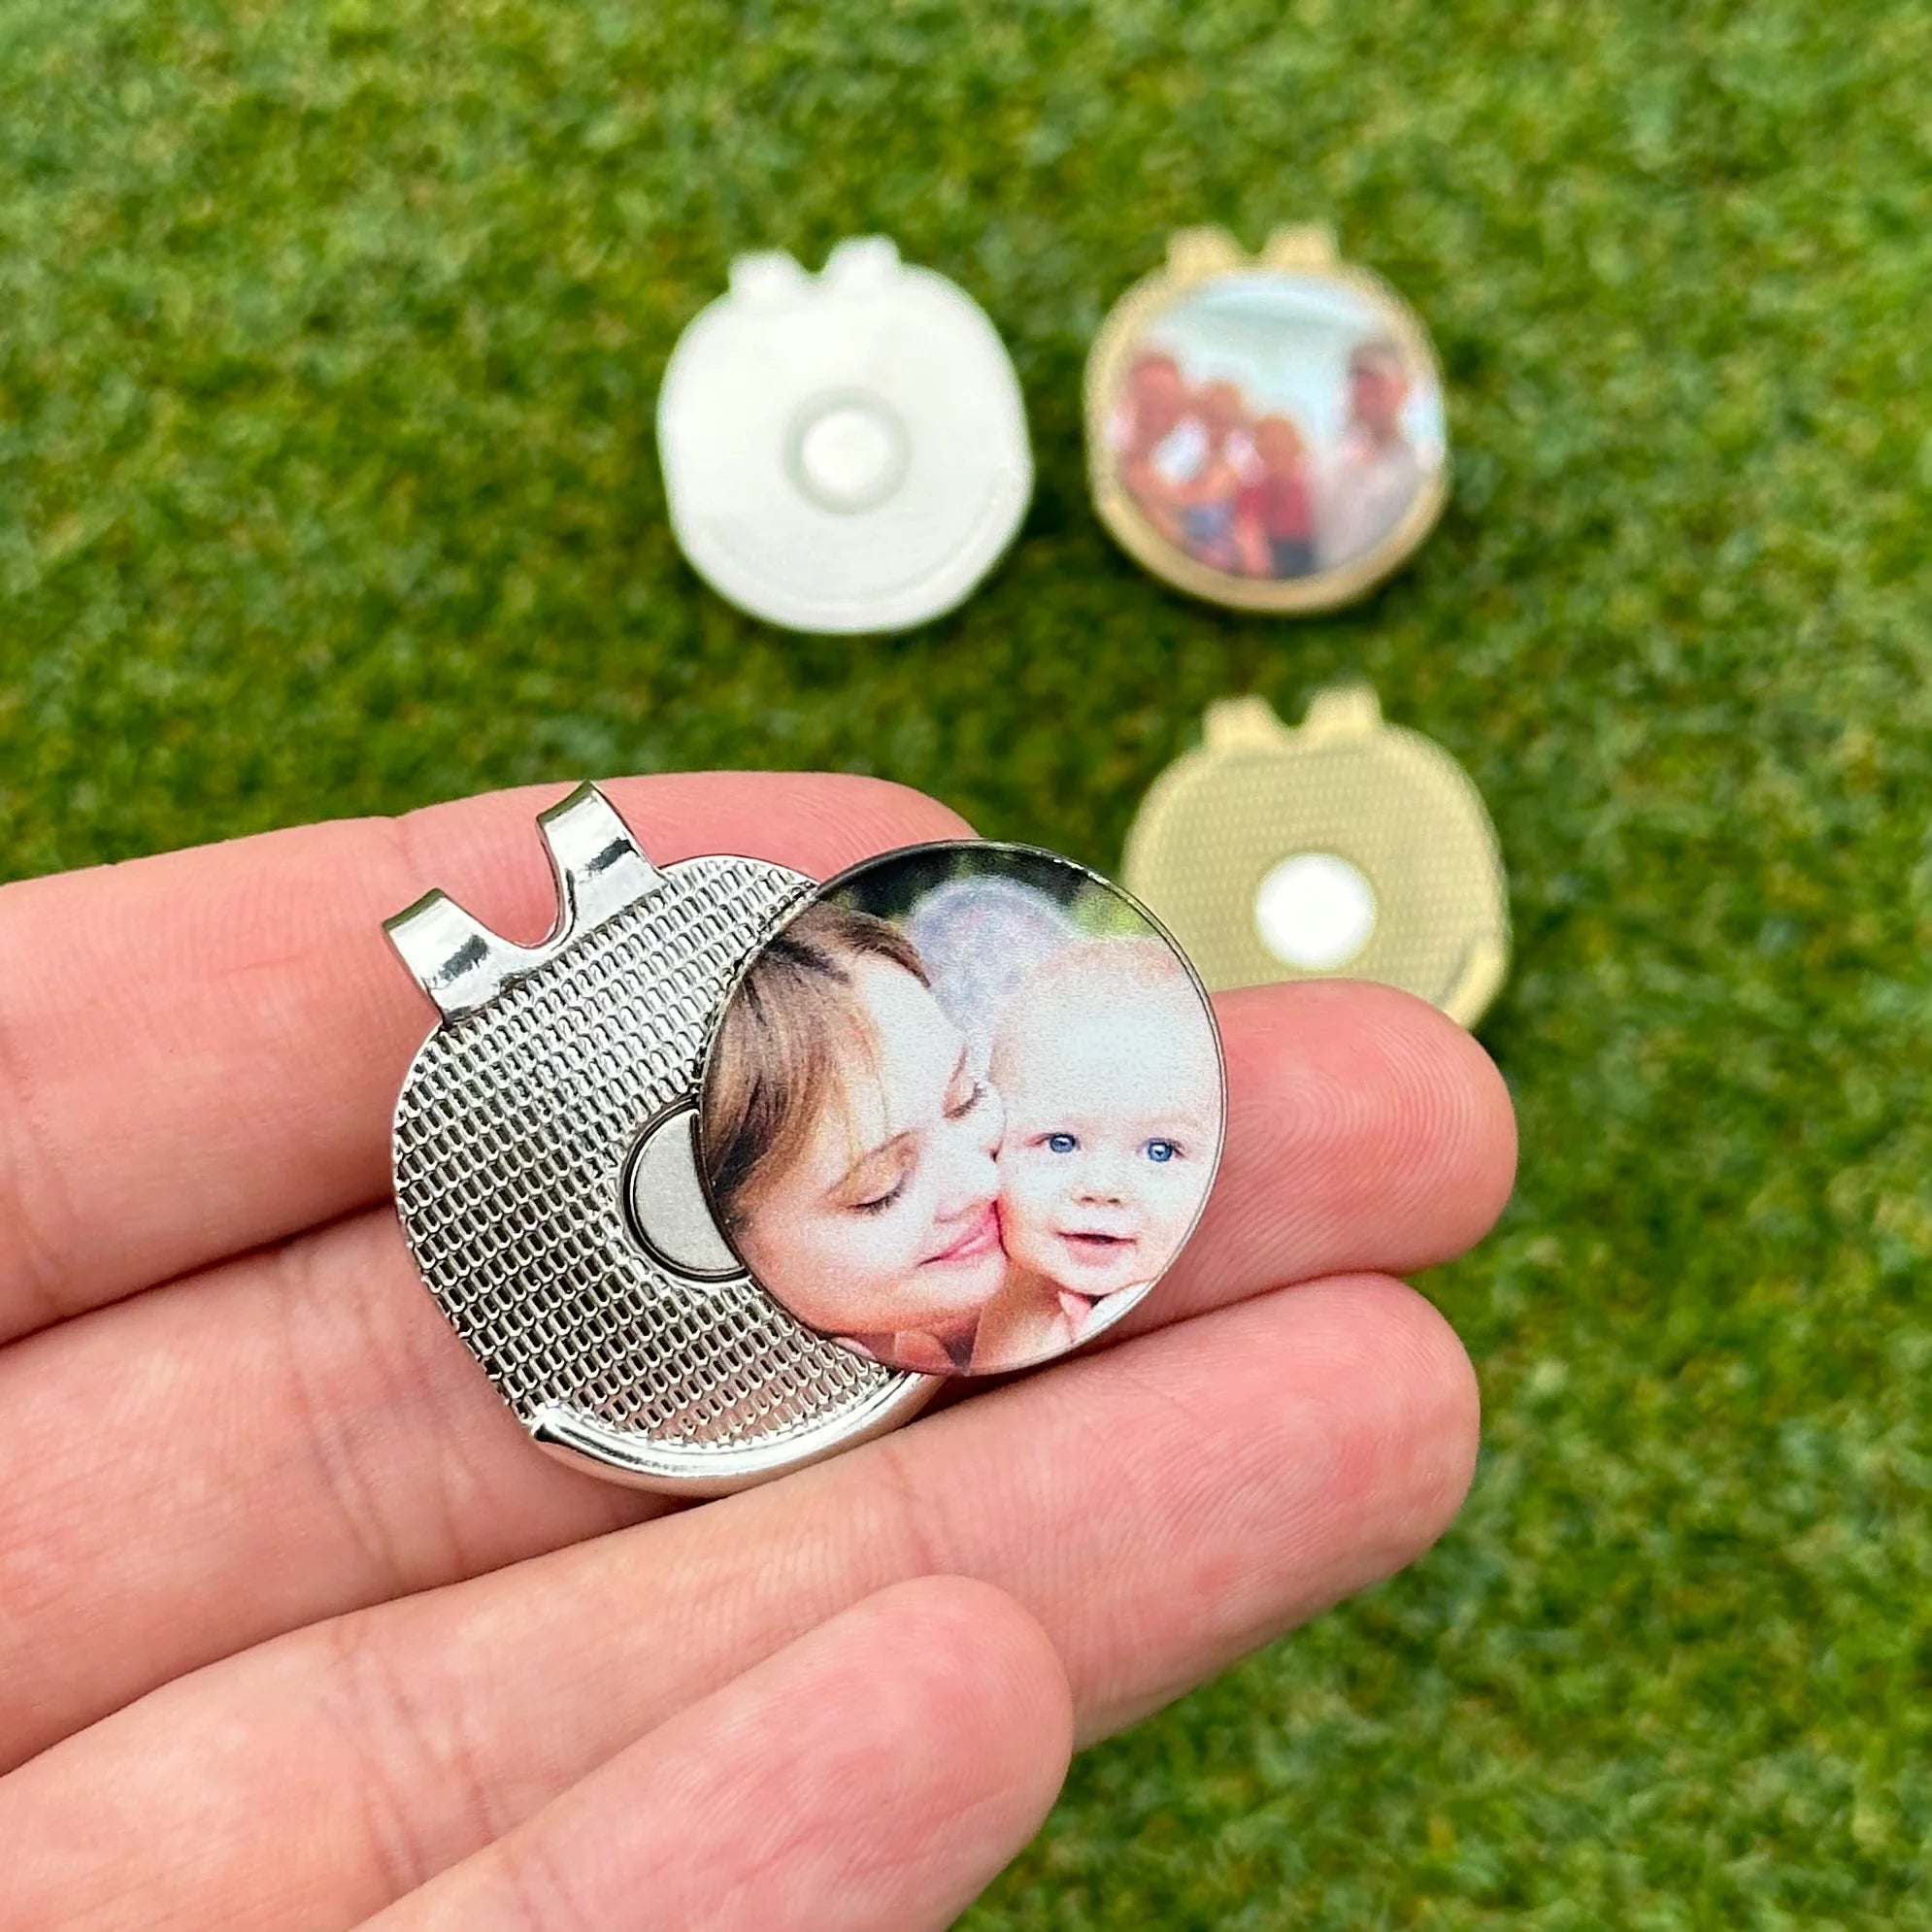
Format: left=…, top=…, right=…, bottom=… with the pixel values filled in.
left=699, top=902, right=931, bottom=1229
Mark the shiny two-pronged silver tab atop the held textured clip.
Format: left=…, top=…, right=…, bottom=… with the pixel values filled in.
left=383, top=784, right=663, bottom=1020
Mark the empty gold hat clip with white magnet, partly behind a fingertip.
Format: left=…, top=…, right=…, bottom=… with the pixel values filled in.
left=1122, top=683, right=1509, bottom=1026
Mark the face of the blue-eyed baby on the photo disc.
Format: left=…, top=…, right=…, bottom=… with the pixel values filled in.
left=993, top=987, right=1219, bottom=1296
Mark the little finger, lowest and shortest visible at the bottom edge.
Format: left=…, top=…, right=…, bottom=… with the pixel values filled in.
left=355, top=1577, right=1072, bottom=1932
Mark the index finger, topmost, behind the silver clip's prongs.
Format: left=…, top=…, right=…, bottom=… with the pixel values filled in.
left=0, top=773, right=968, bottom=1341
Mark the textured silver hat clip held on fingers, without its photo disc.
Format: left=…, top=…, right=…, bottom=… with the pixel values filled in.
left=386, top=784, right=937, bottom=1495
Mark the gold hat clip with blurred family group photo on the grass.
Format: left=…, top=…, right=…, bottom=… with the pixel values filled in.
left=1085, top=228, right=1449, bottom=615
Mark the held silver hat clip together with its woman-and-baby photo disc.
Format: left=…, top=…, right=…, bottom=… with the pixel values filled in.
left=386, top=784, right=1227, bottom=1495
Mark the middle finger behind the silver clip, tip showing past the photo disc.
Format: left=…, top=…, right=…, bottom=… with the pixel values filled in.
left=0, top=983, right=1511, bottom=1768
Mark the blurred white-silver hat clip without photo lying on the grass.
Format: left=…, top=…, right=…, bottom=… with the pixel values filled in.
left=657, top=236, right=1034, bottom=634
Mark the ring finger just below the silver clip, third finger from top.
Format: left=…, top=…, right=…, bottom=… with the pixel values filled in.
left=0, top=1277, right=1476, bottom=1932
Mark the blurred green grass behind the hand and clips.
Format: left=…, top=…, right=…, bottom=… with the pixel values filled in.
left=0, top=0, right=1932, bottom=1932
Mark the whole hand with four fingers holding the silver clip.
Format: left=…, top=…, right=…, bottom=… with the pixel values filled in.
left=0, top=775, right=1513, bottom=1932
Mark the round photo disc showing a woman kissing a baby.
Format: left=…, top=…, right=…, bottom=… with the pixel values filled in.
left=697, top=841, right=1227, bottom=1376
